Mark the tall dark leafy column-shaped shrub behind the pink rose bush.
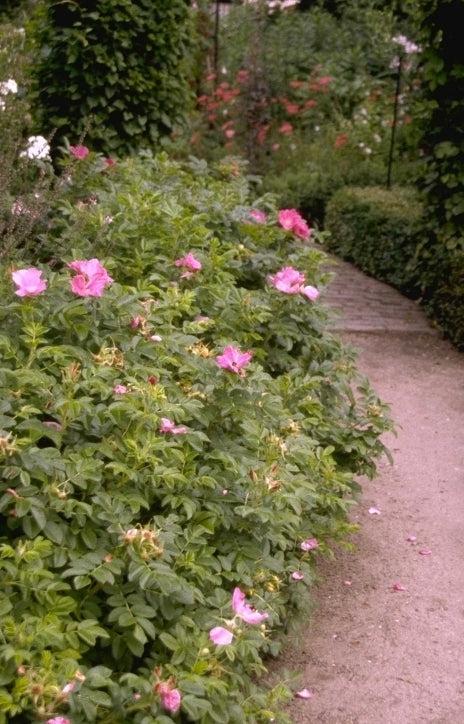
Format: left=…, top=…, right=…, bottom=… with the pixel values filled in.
left=31, top=0, right=193, bottom=155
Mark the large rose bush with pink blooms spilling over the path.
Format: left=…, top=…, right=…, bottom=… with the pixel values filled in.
left=0, top=153, right=391, bottom=724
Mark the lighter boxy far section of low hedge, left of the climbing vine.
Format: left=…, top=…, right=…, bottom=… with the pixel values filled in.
left=325, top=187, right=423, bottom=295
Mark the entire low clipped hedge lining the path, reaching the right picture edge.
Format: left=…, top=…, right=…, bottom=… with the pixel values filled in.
left=325, top=187, right=464, bottom=350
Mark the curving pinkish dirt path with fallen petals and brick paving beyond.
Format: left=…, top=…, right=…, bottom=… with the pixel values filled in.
left=280, top=263, right=464, bottom=724
